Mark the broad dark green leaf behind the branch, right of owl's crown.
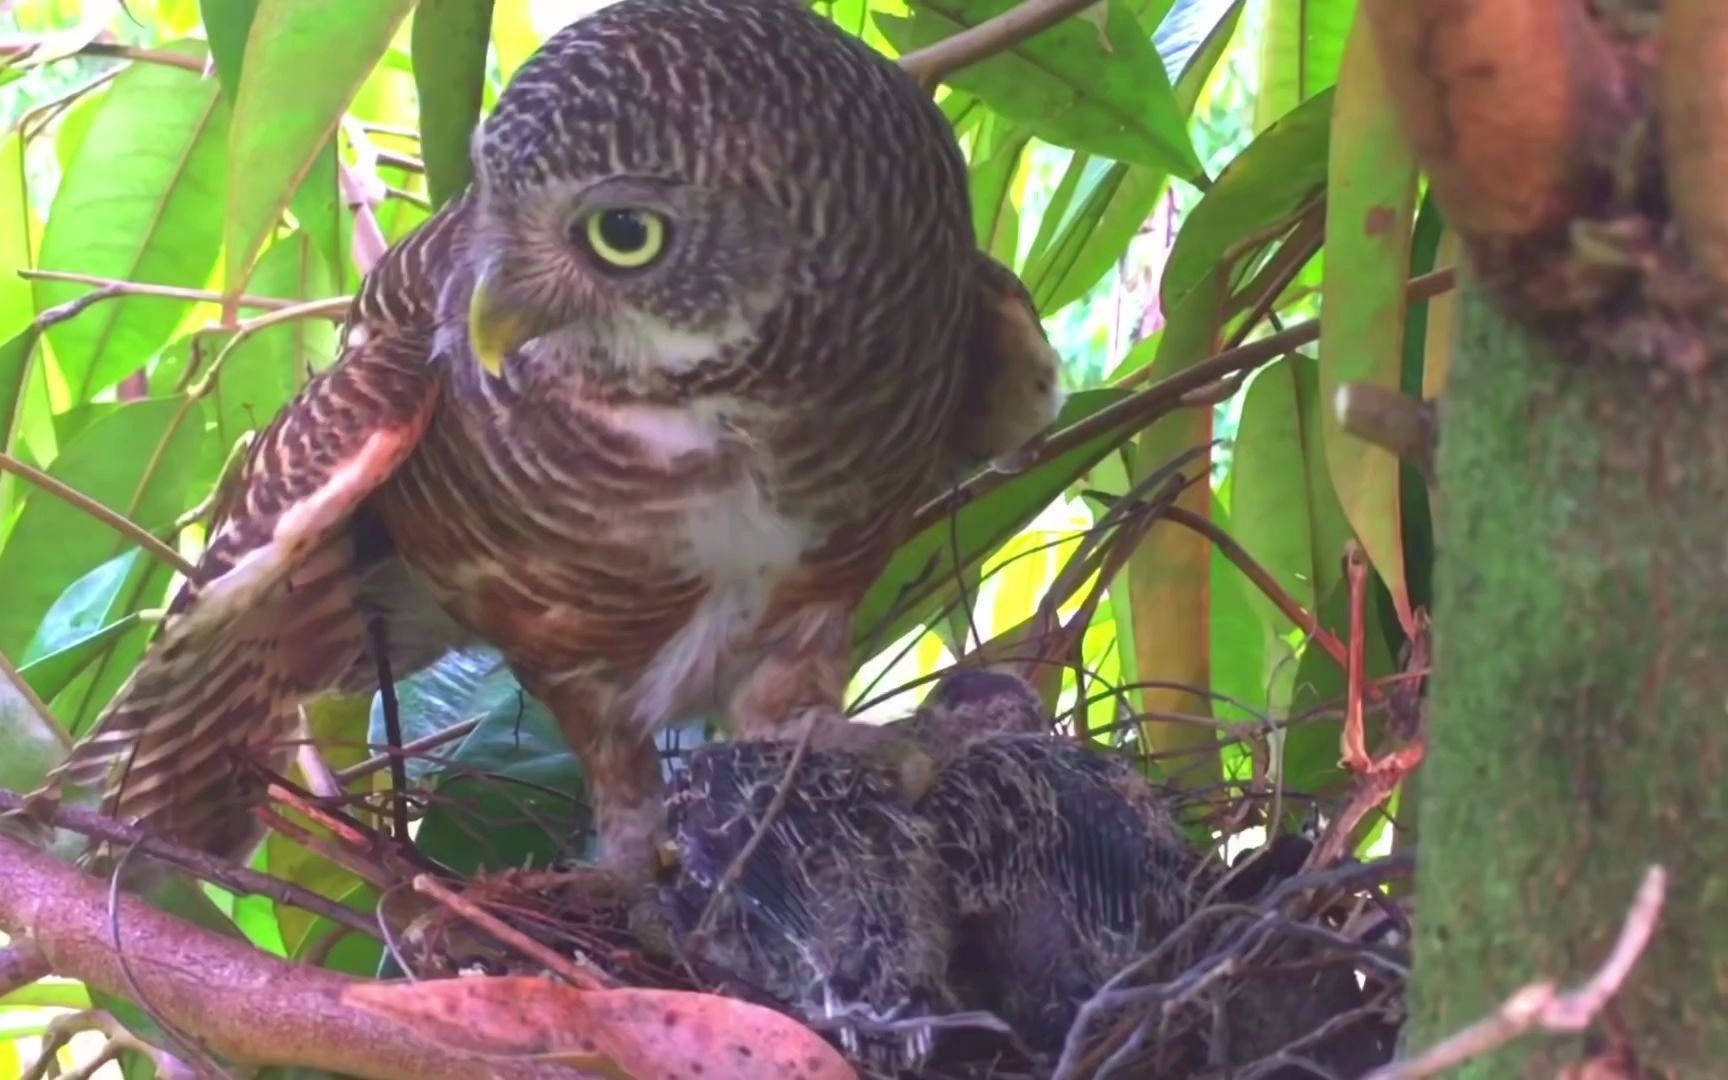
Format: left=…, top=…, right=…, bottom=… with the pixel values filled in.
left=876, top=0, right=1201, bottom=180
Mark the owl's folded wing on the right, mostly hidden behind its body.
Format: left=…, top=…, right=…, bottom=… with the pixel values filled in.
left=949, top=251, right=1063, bottom=470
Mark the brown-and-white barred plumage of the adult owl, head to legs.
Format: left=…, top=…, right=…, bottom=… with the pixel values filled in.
left=20, top=0, right=1058, bottom=876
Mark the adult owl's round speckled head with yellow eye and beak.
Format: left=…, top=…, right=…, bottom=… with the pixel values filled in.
left=468, top=0, right=964, bottom=393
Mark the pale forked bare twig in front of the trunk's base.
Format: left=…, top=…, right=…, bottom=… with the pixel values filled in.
left=1367, top=866, right=1668, bottom=1080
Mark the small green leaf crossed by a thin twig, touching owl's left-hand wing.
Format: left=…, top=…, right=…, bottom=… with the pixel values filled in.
left=214, top=232, right=337, bottom=446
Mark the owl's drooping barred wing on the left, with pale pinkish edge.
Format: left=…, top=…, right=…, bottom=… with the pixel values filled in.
left=18, top=202, right=473, bottom=857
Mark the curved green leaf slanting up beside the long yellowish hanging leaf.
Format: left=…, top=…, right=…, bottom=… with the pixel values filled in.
left=1163, top=92, right=1332, bottom=311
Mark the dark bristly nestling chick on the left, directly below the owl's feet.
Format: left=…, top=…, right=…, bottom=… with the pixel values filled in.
left=664, top=741, right=956, bottom=1070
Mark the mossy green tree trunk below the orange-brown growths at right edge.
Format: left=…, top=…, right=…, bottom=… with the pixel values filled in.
left=1410, top=287, right=1728, bottom=1078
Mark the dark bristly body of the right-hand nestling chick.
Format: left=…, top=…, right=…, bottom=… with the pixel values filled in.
left=919, top=734, right=1196, bottom=1051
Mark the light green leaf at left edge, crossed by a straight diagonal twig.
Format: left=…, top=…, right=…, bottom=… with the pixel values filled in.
left=0, top=397, right=204, bottom=655
